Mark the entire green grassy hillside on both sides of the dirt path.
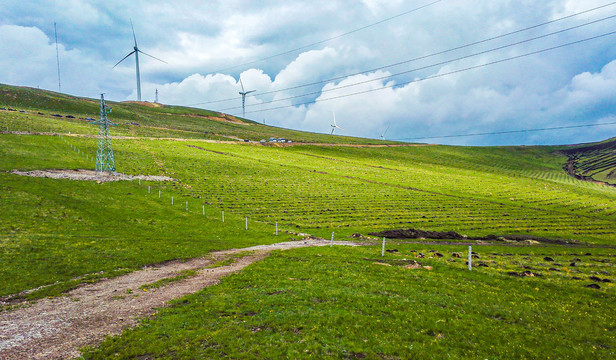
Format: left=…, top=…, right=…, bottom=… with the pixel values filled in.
left=0, top=86, right=616, bottom=358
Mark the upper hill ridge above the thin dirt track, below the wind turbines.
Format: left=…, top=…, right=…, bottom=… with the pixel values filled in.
left=0, top=84, right=399, bottom=145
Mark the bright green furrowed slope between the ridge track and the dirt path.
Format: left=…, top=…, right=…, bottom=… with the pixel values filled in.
left=0, top=131, right=616, bottom=295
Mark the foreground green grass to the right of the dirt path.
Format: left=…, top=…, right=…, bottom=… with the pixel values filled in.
left=84, top=244, right=616, bottom=359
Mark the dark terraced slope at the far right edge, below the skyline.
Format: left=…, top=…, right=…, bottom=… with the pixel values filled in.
left=561, top=138, right=616, bottom=185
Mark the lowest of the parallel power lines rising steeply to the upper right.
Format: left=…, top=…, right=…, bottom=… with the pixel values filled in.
left=235, top=31, right=616, bottom=114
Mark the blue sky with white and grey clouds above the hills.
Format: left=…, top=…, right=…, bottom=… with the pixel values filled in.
left=0, top=0, right=616, bottom=145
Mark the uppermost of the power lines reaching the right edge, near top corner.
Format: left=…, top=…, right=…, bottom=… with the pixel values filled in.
left=186, top=1, right=616, bottom=106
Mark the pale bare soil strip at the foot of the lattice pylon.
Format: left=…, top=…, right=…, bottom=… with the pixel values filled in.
left=10, top=169, right=174, bottom=182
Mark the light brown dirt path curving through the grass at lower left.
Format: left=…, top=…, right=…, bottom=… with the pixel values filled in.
left=0, top=240, right=355, bottom=360
